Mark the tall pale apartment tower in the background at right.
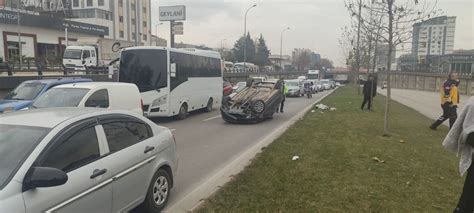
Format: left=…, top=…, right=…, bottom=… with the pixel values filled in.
left=412, top=16, right=456, bottom=61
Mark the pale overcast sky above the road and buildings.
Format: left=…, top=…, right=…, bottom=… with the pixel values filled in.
left=152, top=0, right=474, bottom=66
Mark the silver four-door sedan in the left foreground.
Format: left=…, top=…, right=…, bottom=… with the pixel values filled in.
left=0, top=108, right=177, bottom=213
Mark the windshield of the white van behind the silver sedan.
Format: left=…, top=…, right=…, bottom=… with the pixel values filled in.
left=32, top=88, right=89, bottom=108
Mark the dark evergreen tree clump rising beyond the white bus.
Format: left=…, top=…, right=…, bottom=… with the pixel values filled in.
left=221, top=33, right=270, bottom=66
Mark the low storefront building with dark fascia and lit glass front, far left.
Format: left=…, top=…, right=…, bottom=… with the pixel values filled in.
left=0, top=0, right=109, bottom=63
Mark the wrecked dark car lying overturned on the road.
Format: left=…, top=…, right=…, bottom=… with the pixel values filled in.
left=221, top=81, right=284, bottom=123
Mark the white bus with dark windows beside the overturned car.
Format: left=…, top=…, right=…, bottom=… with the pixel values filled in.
left=119, top=47, right=223, bottom=119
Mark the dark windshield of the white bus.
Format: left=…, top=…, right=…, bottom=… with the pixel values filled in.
left=119, top=49, right=168, bottom=92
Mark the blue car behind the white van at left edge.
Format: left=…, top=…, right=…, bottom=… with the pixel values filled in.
left=0, top=78, right=92, bottom=113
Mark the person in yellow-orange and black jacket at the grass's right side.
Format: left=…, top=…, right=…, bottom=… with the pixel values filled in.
left=430, top=72, right=459, bottom=130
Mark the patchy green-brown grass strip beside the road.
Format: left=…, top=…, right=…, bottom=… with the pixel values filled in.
left=198, top=87, right=464, bottom=212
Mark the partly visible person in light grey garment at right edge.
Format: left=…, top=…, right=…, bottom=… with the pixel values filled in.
left=443, top=98, right=474, bottom=213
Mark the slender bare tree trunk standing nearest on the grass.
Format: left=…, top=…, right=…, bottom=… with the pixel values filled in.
left=383, top=0, right=395, bottom=137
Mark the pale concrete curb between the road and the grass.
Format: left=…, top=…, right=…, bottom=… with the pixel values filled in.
left=164, top=88, right=337, bottom=212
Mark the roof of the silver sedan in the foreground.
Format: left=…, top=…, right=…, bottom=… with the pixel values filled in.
left=0, top=107, right=106, bottom=128
